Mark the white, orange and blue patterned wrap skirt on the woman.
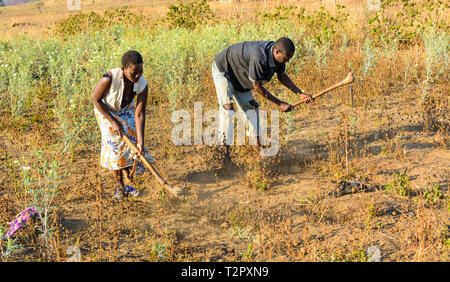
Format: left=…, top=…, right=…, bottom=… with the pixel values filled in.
left=94, top=102, right=155, bottom=174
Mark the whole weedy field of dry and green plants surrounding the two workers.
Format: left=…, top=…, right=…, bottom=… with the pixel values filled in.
left=0, top=0, right=450, bottom=262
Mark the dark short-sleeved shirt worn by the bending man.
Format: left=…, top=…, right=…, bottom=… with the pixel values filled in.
left=214, top=41, right=286, bottom=92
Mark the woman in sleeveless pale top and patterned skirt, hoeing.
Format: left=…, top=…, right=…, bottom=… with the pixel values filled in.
left=92, top=51, right=154, bottom=199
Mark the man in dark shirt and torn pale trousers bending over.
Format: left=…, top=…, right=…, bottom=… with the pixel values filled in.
left=212, top=37, right=314, bottom=160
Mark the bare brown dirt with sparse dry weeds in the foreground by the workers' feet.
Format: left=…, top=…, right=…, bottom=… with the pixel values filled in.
left=1, top=83, right=450, bottom=261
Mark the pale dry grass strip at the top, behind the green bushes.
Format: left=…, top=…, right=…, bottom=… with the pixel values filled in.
left=0, top=0, right=384, bottom=38
